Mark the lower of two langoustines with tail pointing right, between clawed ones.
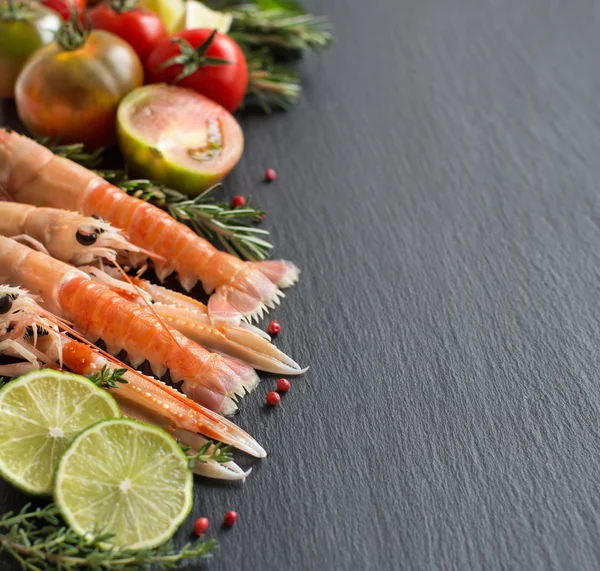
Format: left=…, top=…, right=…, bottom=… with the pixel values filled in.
left=0, top=237, right=258, bottom=414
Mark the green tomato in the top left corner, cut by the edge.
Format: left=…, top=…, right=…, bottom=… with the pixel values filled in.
left=0, top=0, right=62, bottom=99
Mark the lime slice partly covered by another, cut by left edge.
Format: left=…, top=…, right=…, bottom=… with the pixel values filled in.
left=0, top=369, right=119, bottom=495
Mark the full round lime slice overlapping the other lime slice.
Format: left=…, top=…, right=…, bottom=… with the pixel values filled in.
left=54, top=418, right=192, bottom=549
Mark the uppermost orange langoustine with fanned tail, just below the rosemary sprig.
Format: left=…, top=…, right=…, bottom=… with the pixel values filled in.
left=0, top=129, right=299, bottom=322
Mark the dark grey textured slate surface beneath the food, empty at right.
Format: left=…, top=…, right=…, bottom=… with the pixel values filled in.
left=2, top=0, right=600, bottom=571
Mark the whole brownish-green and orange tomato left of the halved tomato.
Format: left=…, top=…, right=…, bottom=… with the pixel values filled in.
left=15, top=29, right=144, bottom=149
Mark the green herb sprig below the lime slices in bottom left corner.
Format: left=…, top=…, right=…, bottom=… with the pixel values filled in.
left=0, top=504, right=216, bottom=571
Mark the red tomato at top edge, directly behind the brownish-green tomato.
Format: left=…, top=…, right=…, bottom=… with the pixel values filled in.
left=88, top=1, right=167, bottom=63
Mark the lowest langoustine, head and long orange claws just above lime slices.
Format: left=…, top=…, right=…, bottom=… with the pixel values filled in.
left=0, top=285, right=266, bottom=480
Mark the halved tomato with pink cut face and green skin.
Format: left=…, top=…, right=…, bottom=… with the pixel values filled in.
left=117, top=84, right=244, bottom=194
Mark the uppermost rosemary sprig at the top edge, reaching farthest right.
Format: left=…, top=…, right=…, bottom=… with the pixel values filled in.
left=227, top=0, right=333, bottom=55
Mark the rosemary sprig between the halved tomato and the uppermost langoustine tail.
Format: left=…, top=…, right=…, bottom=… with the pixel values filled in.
left=120, top=180, right=273, bottom=261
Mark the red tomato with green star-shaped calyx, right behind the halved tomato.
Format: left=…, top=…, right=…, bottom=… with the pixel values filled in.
left=146, top=29, right=248, bottom=111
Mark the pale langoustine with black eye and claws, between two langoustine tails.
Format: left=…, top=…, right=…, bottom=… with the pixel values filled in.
left=0, top=201, right=306, bottom=375
